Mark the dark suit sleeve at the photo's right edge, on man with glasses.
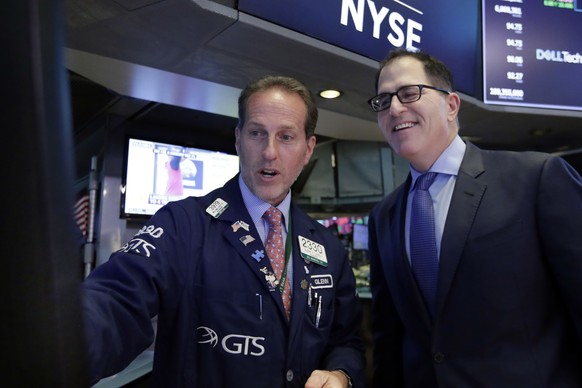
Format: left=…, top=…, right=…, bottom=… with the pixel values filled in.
left=536, top=157, right=582, bottom=344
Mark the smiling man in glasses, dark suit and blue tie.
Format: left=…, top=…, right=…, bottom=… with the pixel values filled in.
left=369, top=49, right=582, bottom=388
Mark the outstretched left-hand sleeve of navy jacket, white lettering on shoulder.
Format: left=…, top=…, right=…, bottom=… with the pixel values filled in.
left=82, top=204, right=192, bottom=383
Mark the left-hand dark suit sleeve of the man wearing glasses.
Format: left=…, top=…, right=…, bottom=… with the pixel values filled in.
left=368, top=211, right=403, bottom=387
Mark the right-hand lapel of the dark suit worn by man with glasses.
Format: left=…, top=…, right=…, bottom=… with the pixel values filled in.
left=437, top=143, right=487, bottom=317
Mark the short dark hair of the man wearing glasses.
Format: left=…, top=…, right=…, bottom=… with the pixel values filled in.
left=376, top=48, right=455, bottom=91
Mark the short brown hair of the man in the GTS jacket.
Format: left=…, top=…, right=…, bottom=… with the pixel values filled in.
left=238, top=76, right=318, bottom=139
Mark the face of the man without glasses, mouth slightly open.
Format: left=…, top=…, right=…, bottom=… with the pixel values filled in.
left=235, top=88, right=315, bottom=206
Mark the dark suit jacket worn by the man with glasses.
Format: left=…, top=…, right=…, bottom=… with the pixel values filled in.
left=369, top=144, right=582, bottom=388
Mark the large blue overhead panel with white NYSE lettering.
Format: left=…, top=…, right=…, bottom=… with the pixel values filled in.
left=238, top=0, right=481, bottom=97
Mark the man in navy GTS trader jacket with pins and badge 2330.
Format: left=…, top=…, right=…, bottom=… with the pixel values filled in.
left=83, top=77, right=363, bottom=388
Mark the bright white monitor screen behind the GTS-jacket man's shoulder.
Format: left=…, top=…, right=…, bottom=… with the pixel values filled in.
left=121, top=138, right=239, bottom=218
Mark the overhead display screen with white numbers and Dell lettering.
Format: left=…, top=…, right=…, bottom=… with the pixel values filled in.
left=482, top=0, right=582, bottom=110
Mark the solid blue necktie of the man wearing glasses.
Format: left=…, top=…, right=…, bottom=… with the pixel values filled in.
left=410, top=172, right=439, bottom=316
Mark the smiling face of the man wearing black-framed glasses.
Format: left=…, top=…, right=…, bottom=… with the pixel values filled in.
left=378, top=57, right=460, bottom=172
